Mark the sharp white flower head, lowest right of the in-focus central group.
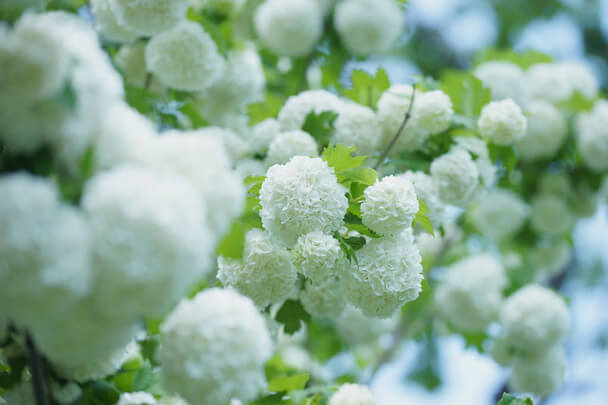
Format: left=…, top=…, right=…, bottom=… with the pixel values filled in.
left=344, top=228, right=422, bottom=318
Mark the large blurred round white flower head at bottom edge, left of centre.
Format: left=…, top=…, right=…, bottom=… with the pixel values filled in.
left=158, top=288, right=272, bottom=405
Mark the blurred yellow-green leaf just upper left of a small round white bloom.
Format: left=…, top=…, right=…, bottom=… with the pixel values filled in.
left=439, top=70, right=491, bottom=118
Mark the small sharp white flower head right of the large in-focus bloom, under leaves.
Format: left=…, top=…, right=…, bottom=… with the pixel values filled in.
left=361, top=176, right=418, bottom=235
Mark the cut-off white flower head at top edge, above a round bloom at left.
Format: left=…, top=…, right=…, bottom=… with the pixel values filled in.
left=108, top=0, right=188, bottom=36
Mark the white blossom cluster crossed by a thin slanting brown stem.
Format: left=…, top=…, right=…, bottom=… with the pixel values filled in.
left=378, top=84, right=454, bottom=153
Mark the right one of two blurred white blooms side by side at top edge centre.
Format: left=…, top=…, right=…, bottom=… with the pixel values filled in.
left=334, top=0, right=405, bottom=56
